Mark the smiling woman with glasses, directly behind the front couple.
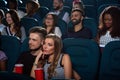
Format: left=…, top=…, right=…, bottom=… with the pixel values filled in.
left=43, top=12, right=62, bottom=37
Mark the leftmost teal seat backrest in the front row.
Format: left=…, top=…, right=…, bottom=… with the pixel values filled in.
left=0, top=35, right=21, bottom=71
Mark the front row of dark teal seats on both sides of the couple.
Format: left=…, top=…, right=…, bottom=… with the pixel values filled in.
left=0, top=36, right=120, bottom=80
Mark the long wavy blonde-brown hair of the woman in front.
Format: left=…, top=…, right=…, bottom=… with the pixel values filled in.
left=38, top=34, right=63, bottom=79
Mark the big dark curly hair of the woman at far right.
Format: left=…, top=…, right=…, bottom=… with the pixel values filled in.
left=99, top=6, right=120, bottom=38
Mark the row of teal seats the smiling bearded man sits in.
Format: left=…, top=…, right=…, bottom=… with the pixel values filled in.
left=21, top=18, right=97, bottom=38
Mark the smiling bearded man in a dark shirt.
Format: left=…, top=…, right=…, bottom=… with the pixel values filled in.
left=68, top=9, right=92, bottom=39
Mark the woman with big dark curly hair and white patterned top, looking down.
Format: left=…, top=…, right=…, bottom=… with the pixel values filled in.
left=96, top=6, right=120, bottom=47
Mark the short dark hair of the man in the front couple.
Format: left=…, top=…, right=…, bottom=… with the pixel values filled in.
left=29, top=26, right=47, bottom=39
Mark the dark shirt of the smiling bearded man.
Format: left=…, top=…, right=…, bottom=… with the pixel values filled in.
left=67, top=27, right=92, bottom=39
